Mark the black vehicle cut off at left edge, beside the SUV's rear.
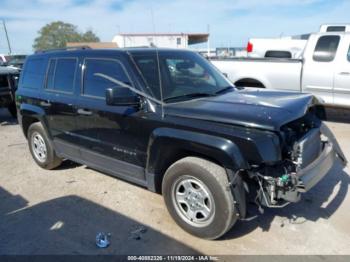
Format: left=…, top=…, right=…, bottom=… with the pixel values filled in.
left=0, top=66, right=19, bottom=117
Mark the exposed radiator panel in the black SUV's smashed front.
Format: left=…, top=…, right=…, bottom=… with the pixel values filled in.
left=293, top=128, right=322, bottom=169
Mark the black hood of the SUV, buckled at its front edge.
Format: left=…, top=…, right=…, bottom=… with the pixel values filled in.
left=164, top=89, right=320, bottom=130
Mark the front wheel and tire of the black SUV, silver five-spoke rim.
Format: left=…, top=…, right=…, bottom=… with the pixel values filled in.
left=162, top=157, right=238, bottom=239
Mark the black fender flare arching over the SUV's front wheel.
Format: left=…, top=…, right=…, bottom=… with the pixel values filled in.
left=146, top=128, right=248, bottom=193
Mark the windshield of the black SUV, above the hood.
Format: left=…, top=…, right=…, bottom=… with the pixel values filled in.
left=132, top=50, right=233, bottom=102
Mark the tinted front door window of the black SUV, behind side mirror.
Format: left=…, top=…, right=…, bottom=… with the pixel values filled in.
left=83, top=59, right=132, bottom=97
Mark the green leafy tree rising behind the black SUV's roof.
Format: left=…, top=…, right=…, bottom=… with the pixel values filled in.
left=33, top=21, right=100, bottom=50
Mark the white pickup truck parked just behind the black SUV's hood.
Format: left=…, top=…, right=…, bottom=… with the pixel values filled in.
left=212, top=32, right=350, bottom=107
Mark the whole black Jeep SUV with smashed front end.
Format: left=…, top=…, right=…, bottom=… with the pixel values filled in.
left=16, top=48, right=346, bottom=239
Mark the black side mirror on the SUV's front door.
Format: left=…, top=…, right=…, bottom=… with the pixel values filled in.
left=106, top=86, right=140, bottom=106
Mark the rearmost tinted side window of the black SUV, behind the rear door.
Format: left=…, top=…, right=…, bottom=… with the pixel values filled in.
left=22, top=58, right=46, bottom=88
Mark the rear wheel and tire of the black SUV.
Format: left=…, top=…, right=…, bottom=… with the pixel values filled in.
left=27, top=122, right=62, bottom=169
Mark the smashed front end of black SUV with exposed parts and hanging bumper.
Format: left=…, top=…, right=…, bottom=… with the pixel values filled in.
left=249, top=113, right=347, bottom=208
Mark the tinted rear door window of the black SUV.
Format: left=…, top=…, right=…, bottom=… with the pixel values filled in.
left=46, top=58, right=78, bottom=93
